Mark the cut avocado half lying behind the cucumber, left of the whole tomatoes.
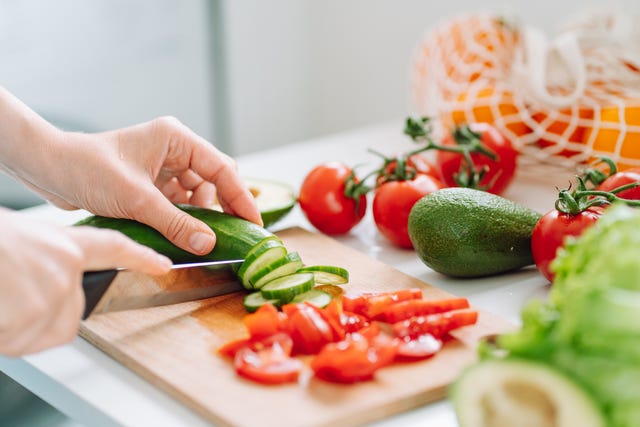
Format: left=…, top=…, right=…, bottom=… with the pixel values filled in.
left=211, top=177, right=298, bottom=228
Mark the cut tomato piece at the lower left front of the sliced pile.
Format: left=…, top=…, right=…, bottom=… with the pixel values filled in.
left=233, top=334, right=304, bottom=384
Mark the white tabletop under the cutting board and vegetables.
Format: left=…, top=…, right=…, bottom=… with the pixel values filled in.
left=0, top=119, right=570, bottom=427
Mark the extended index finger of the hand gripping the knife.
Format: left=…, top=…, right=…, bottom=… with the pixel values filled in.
left=68, top=227, right=171, bottom=275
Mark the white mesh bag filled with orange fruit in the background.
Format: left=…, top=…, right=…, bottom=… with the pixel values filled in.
left=410, top=12, right=640, bottom=170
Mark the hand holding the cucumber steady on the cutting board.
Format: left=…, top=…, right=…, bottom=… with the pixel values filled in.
left=5, top=112, right=262, bottom=255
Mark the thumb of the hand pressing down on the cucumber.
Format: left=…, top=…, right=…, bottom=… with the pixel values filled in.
left=134, top=191, right=216, bottom=255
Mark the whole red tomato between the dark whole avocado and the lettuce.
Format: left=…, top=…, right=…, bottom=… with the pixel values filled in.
left=531, top=208, right=602, bottom=282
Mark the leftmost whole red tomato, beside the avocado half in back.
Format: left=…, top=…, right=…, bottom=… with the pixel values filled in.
left=298, top=162, right=367, bottom=234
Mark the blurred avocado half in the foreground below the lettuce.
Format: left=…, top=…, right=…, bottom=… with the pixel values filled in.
left=452, top=359, right=606, bottom=427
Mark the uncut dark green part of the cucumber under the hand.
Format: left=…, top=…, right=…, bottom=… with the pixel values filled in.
left=75, top=205, right=275, bottom=263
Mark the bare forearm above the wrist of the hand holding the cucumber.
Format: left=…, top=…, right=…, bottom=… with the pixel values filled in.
left=0, top=87, right=63, bottom=182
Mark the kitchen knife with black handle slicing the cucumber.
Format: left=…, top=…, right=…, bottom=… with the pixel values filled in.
left=82, top=259, right=244, bottom=320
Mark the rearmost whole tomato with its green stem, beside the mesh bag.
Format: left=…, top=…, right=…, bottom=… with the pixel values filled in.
left=436, top=123, right=518, bottom=194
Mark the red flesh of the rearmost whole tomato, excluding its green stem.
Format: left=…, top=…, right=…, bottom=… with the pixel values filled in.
left=436, top=123, right=518, bottom=194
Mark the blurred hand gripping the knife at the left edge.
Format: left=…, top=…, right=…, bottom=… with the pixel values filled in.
left=0, top=211, right=171, bottom=356
